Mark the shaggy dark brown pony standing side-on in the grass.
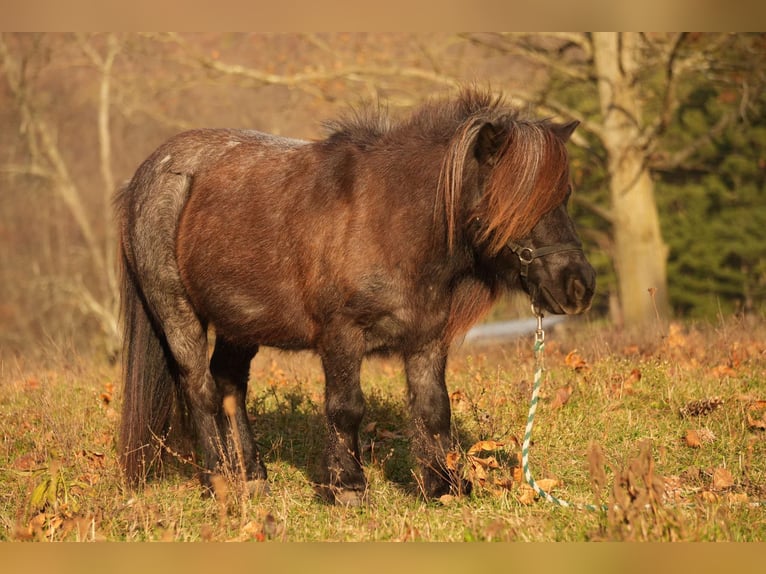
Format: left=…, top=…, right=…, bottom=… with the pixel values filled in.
left=116, top=89, right=595, bottom=503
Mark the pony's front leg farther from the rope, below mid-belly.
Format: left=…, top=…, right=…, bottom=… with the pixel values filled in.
left=321, top=349, right=367, bottom=506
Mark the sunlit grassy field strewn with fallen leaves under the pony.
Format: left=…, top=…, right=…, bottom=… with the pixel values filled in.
left=0, top=319, right=766, bottom=541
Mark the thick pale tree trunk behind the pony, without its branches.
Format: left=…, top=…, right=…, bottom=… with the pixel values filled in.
left=593, top=32, right=668, bottom=328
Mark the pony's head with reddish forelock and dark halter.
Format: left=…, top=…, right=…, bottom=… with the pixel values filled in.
left=440, top=97, right=595, bottom=314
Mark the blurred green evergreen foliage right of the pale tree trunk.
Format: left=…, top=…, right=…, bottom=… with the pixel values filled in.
left=657, top=85, right=766, bottom=318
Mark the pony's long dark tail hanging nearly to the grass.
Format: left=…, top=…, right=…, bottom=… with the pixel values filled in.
left=119, top=246, right=179, bottom=487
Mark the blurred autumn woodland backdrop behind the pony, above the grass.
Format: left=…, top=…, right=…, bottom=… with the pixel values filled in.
left=0, top=33, right=766, bottom=360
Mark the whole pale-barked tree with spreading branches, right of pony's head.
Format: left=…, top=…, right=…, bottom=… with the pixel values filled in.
left=470, top=33, right=760, bottom=327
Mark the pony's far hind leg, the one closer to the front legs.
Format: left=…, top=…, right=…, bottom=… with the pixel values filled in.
left=210, top=337, right=266, bottom=489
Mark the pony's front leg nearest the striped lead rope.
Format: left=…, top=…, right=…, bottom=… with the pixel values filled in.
left=404, top=343, right=470, bottom=498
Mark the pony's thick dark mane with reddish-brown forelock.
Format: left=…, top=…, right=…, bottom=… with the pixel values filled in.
left=325, top=88, right=569, bottom=255
